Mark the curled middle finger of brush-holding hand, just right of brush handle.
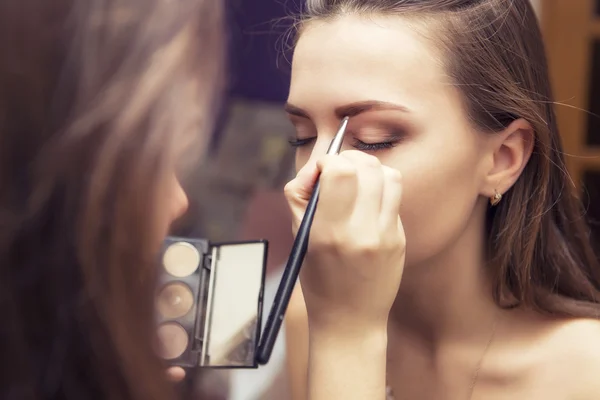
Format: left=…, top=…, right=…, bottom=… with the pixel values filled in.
left=315, top=155, right=358, bottom=223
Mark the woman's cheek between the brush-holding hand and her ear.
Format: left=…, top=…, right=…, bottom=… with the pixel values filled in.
left=396, top=140, right=478, bottom=265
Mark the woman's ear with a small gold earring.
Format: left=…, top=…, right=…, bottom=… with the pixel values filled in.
left=481, top=118, right=535, bottom=197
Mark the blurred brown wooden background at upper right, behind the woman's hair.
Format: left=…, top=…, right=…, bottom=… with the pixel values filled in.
left=537, top=0, right=600, bottom=254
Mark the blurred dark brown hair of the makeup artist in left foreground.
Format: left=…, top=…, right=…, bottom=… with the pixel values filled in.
left=0, top=0, right=223, bottom=400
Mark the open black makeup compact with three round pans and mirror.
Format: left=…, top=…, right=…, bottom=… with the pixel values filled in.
left=156, top=237, right=268, bottom=368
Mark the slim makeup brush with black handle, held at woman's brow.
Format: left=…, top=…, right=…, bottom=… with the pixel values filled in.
left=256, top=117, right=349, bottom=365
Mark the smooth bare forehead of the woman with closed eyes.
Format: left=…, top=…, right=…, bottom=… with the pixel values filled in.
left=288, top=15, right=449, bottom=117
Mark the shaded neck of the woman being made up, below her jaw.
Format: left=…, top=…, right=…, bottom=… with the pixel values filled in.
left=390, top=209, right=498, bottom=348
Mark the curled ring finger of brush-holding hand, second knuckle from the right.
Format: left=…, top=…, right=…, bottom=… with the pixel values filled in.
left=340, top=150, right=384, bottom=222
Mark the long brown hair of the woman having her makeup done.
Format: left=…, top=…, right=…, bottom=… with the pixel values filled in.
left=299, top=0, right=600, bottom=318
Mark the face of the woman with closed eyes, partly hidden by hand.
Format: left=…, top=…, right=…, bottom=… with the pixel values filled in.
left=287, top=16, right=489, bottom=265
